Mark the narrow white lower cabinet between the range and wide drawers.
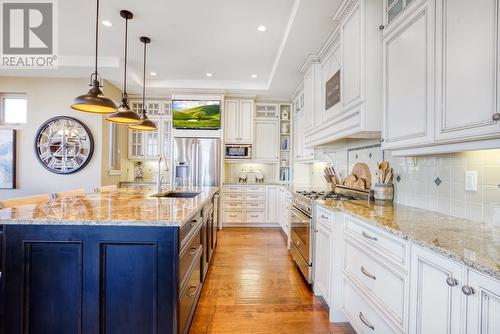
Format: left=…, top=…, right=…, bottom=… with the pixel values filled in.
left=314, top=208, right=333, bottom=304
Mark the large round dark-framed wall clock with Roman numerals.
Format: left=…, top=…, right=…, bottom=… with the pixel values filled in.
left=35, top=116, right=94, bottom=174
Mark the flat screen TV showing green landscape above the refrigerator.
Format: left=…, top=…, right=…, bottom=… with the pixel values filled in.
left=172, top=100, right=221, bottom=130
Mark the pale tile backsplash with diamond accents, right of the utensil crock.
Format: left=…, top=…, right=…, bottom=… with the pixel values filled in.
left=386, top=150, right=500, bottom=224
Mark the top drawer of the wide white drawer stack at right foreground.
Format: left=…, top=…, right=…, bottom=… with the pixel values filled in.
left=345, top=216, right=407, bottom=269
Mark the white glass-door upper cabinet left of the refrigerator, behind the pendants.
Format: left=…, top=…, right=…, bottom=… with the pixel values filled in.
left=128, top=100, right=172, bottom=160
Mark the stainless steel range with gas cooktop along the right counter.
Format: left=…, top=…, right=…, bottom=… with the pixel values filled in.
left=289, top=191, right=355, bottom=284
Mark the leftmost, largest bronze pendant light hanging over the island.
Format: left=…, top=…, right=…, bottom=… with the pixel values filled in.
left=71, top=0, right=116, bottom=114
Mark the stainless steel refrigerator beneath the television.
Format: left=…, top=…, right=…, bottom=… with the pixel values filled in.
left=172, top=138, right=221, bottom=186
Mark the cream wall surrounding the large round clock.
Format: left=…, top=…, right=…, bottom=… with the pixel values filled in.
left=0, top=77, right=120, bottom=199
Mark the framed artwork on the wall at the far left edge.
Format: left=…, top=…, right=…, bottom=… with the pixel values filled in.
left=0, top=129, right=16, bottom=189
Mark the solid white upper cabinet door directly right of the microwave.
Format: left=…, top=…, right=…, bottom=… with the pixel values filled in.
left=253, top=120, right=280, bottom=162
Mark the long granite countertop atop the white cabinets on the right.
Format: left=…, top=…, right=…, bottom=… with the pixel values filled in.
left=316, top=199, right=500, bottom=280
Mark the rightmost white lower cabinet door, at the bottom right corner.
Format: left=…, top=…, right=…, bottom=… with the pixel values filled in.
left=466, top=270, right=500, bottom=334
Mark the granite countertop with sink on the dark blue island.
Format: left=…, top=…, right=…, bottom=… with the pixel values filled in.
left=0, top=186, right=219, bottom=227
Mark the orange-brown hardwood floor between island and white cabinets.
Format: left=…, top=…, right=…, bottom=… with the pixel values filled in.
left=189, top=228, right=354, bottom=334
